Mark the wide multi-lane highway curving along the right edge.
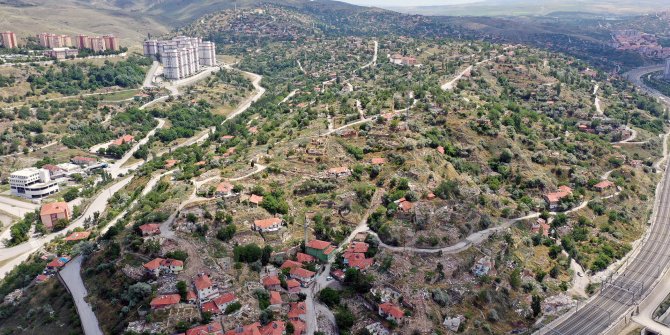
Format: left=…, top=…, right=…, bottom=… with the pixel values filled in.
left=538, top=67, right=670, bottom=335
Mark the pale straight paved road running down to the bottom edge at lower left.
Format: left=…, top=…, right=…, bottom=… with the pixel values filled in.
left=60, top=256, right=103, bottom=335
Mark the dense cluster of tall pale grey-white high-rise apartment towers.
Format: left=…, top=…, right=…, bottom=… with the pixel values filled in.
left=144, top=36, right=216, bottom=80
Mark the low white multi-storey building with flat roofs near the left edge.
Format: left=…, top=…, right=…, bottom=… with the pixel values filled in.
left=9, top=167, right=58, bottom=199
